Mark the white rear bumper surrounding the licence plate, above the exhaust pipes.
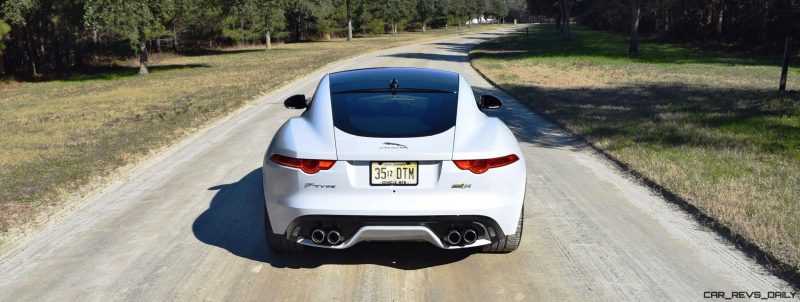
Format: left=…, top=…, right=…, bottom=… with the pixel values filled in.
left=263, top=162, right=525, bottom=234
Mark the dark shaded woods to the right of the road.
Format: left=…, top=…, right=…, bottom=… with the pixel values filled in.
left=527, top=0, right=800, bottom=55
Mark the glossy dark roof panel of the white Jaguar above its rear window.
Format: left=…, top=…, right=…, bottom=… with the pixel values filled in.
left=330, top=67, right=458, bottom=93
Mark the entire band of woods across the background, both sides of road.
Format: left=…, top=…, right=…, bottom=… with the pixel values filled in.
left=0, top=0, right=800, bottom=80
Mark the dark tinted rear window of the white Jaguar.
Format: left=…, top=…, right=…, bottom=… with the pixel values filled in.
left=332, top=92, right=458, bottom=137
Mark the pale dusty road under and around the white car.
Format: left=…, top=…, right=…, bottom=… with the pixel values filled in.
left=0, top=26, right=791, bottom=301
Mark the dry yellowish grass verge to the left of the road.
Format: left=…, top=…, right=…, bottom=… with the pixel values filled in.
left=0, top=26, right=510, bottom=237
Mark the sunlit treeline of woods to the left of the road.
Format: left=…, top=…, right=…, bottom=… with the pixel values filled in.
left=0, top=0, right=524, bottom=79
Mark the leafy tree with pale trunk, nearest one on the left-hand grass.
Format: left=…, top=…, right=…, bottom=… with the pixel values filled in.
left=85, top=0, right=169, bottom=74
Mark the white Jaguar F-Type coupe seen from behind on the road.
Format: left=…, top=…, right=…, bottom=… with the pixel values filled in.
left=262, top=68, right=526, bottom=252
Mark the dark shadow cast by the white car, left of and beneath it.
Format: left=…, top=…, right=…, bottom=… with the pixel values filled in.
left=192, top=168, right=475, bottom=270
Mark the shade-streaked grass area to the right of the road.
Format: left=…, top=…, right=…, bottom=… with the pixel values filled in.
left=471, top=25, right=800, bottom=266
